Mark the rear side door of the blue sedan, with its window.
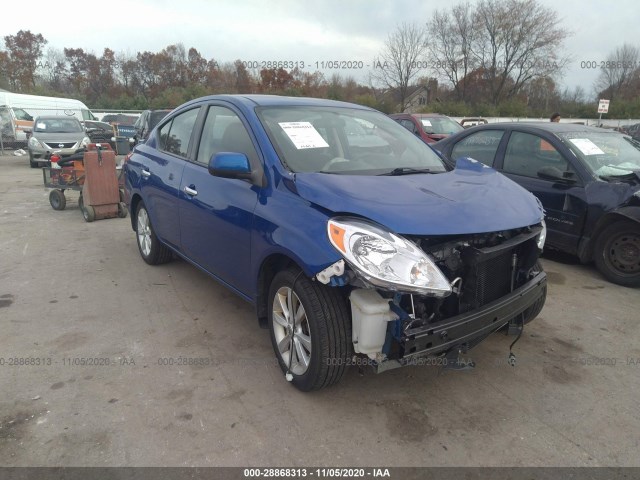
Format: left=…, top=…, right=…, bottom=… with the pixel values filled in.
left=136, top=107, right=200, bottom=249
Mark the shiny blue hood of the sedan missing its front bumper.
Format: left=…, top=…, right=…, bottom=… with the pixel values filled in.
left=295, top=159, right=543, bottom=235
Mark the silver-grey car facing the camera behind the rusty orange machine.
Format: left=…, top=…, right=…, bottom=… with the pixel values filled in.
left=28, top=115, right=91, bottom=168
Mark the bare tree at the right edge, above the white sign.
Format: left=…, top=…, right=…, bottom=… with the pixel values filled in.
left=595, top=43, right=640, bottom=100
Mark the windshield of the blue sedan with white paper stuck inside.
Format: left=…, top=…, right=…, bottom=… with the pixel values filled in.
left=257, top=106, right=446, bottom=175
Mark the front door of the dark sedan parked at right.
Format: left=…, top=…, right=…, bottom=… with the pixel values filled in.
left=498, top=130, right=587, bottom=253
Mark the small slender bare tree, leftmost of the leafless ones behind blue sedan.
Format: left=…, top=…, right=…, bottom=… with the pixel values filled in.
left=371, top=23, right=427, bottom=111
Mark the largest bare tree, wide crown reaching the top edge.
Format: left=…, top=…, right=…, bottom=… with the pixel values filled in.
left=471, top=0, right=570, bottom=104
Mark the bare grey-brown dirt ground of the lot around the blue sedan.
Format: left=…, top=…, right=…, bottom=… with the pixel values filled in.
left=0, top=156, right=640, bottom=467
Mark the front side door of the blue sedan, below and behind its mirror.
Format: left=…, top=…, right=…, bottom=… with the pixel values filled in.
left=180, top=104, right=262, bottom=294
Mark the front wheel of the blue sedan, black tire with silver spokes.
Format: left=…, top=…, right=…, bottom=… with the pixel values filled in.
left=268, top=269, right=352, bottom=392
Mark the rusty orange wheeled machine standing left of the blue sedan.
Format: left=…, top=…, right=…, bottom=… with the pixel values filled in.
left=43, top=144, right=127, bottom=222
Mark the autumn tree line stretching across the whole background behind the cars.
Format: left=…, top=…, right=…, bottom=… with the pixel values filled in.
left=0, top=0, right=640, bottom=118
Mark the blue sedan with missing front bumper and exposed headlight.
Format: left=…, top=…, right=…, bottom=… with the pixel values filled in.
left=124, top=95, right=546, bottom=391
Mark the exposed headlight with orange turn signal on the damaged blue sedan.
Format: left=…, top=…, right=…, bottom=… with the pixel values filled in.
left=327, top=217, right=451, bottom=297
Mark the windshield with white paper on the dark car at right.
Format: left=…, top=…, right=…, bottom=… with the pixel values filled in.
left=559, top=132, right=640, bottom=177
